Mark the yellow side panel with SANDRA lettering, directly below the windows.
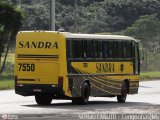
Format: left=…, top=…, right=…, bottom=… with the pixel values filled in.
left=71, top=62, right=133, bottom=74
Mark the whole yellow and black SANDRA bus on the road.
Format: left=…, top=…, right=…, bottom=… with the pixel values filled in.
left=15, top=31, right=140, bottom=105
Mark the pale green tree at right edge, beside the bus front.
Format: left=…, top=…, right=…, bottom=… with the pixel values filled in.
left=124, top=14, right=160, bottom=70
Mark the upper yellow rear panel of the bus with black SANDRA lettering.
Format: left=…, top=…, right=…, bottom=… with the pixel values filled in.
left=16, top=32, right=60, bottom=55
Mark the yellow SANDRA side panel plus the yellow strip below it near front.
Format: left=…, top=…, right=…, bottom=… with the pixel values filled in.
left=71, top=62, right=139, bottom=81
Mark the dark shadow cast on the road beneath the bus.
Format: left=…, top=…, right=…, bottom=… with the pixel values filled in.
left=22, top=101, right=160, bottom=110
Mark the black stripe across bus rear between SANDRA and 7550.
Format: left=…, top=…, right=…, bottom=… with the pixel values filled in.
left=17, top=54, right=59, bottom=58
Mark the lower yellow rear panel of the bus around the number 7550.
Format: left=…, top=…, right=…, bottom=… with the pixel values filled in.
left=17, top=60, right=59, bottom=84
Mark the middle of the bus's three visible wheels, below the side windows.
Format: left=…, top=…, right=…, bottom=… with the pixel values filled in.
left=72, top=82, right=90, bottom=105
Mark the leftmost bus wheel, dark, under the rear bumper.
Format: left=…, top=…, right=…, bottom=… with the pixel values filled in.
left=35, top=94, right=52, bottom=105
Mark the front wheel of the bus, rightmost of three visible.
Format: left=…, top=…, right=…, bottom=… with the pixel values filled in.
left=117, top=82, right=127, bottom=103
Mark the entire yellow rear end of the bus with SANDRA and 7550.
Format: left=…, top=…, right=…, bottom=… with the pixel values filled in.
left=15, top=32, right=63, bottom=104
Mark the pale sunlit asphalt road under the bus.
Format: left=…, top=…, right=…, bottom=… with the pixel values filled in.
left=0, top=80, right=160, bottom=120
